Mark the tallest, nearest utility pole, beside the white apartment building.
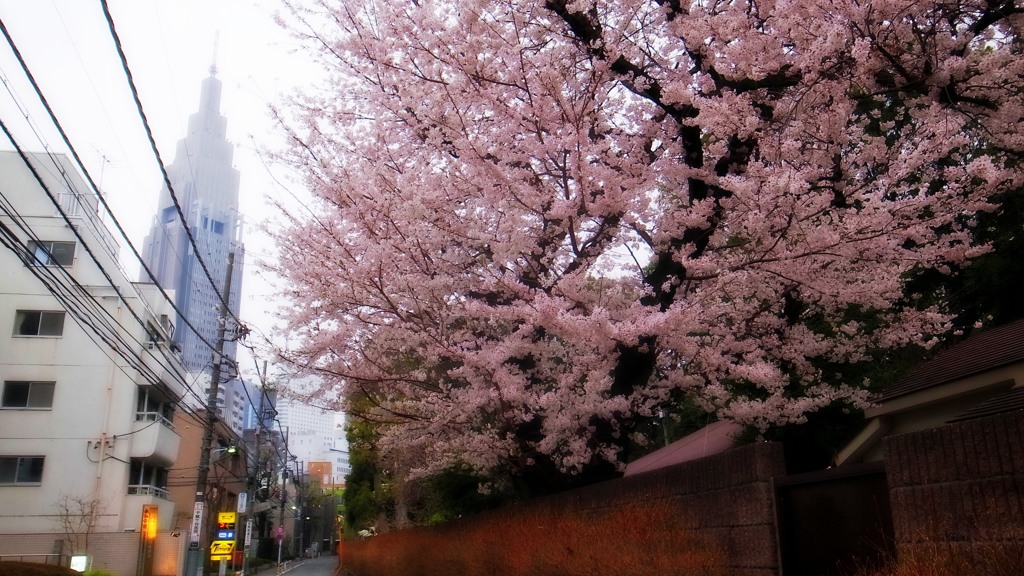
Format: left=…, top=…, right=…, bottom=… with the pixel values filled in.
left=185, top=252, right=234, bottom=576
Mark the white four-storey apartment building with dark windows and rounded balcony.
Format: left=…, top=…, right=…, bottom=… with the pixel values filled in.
left=0, top=152, right=185, bottom=576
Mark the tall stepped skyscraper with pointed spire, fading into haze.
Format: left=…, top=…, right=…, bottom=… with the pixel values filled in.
left=142, top=66, right=244, bottom=372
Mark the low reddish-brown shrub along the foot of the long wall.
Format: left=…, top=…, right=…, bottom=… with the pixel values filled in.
left=344, top=504, right=729, bottom=576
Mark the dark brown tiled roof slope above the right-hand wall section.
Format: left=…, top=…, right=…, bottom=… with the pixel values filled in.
left=873, top=319, right=1024, bottom=402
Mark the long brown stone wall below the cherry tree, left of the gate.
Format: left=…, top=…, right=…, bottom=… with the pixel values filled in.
left=345, top=443, right=784, bottom=576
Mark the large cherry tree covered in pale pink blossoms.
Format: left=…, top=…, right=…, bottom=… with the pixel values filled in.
left=268, top=0, right=1024, bottom=481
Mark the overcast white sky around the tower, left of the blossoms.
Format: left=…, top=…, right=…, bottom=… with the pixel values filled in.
left=0, top=0, right=318, bottom=381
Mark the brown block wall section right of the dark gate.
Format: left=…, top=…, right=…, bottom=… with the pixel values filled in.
left=886, top=411, right=1024, bottom=574
